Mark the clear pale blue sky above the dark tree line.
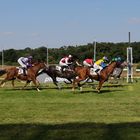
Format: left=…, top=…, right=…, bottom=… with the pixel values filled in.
left=0, top=0, right=140, bottom=50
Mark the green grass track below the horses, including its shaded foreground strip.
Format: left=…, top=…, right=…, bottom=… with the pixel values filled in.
left=0, top=82, right=140, bottom=140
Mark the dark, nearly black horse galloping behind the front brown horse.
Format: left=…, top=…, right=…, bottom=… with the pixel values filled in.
left=38, top=65, right=76, bottom=89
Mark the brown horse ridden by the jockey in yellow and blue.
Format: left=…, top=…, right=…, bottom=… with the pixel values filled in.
left=72, top=62, right=118, bottom=93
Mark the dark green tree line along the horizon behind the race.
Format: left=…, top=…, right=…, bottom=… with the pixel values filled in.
left=0, top=42, right=140, bottom=65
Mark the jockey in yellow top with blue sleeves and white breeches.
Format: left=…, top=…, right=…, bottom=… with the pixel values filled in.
left=94, top=56, right=108, bottom=72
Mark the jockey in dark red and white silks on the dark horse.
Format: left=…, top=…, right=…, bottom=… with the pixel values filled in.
left=59, top=55, right=73, bottom=72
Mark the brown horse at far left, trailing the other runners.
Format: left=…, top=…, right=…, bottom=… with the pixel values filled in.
left=0, top=63, right=46, bottom=91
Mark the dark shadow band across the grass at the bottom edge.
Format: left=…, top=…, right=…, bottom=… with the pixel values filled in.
left=0, top=122, right=140, bottom=140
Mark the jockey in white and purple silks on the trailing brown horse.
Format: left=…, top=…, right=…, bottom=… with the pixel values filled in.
left=17, top=56, right=33, bottom=75
